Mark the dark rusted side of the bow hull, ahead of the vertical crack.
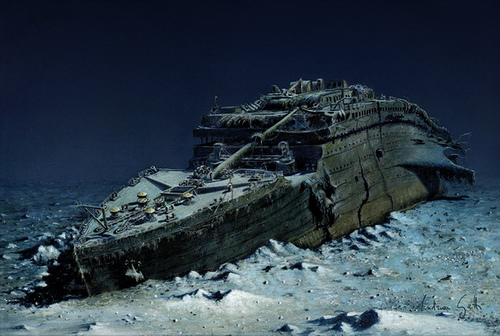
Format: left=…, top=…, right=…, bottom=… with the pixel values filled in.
left=75, top=178, right=316, bottom=295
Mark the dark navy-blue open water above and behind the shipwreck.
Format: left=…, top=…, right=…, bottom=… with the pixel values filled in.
left=0, top=0, right=500, bottom=182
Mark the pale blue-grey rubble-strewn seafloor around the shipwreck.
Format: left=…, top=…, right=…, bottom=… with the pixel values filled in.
left=0, top=178, right=500, bottom=335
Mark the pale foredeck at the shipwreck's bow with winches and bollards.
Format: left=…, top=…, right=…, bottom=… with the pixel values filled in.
left=76, top=169, right=312, bottom=247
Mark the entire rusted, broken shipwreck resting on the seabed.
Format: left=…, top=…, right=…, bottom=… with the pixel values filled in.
left=74, top=79, right=474, bottom=295
